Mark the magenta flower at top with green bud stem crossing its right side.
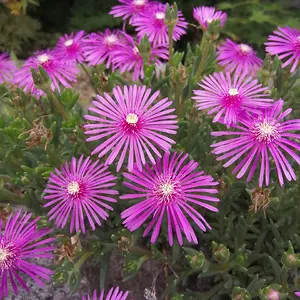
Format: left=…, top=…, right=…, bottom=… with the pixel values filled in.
left=132, top=4, right=188, bottom=45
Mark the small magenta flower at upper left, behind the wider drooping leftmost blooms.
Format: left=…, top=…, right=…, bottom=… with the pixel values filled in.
left=53, top=30, right=85, bottom=63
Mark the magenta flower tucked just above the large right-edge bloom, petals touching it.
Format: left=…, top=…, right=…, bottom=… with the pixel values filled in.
left=192, top=72, right=273, bottom=127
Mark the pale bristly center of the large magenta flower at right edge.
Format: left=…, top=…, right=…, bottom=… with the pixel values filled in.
left=251, top=119, right=282, bottom=143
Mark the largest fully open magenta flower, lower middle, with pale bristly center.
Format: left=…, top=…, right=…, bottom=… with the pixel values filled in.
left=120, top=153, right=219, bottom=245
